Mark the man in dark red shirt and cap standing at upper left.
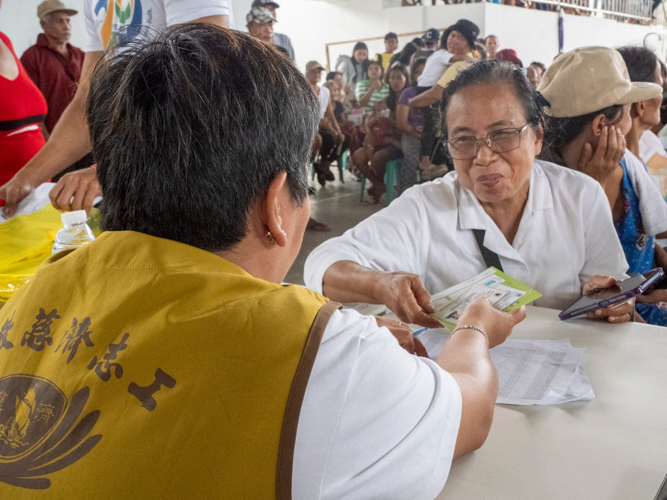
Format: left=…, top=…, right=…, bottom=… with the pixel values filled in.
left=21, top=0, right=95, bottom=182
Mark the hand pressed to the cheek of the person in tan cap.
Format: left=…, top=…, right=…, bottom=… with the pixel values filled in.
left=578, top=125, right=625, bottom=186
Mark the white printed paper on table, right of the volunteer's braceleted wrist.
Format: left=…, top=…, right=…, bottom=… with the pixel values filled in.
left=490, top=339, right=595, bottom=405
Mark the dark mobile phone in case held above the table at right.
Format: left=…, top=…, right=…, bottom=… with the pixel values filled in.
left=558, top=267, right=665, bottom=321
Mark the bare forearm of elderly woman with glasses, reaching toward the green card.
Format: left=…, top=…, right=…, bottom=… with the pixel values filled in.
left=322, top=260, right=384, bottom=304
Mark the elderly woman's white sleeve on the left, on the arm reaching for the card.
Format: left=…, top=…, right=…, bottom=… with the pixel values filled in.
left=304, top=189, right=430, bottom=293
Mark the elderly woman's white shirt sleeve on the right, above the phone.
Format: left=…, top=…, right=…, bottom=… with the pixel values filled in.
left=573, top=182, right=628, bottom=288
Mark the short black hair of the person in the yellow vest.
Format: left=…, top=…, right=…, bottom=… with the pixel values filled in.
left=87, top=23, right=319, bottom=251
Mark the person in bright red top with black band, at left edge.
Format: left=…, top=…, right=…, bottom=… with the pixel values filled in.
left=0, top=32, right=47, bottom=186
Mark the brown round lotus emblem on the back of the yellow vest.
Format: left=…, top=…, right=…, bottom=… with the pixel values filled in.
left=0, top=374, right=102, bottom=489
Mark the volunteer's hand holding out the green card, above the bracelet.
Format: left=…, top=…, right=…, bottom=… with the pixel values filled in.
left=456, top=297, right=526, bottom=348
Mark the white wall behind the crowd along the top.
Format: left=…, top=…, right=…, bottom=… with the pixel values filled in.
left=0, top=0, right=651, bottom=69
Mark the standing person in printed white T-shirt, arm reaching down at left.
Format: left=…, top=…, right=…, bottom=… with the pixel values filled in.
left=0, top=0, right=234, bottom=217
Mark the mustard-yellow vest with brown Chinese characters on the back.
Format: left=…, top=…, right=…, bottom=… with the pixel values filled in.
left=0, top=232, right=338, bottom=500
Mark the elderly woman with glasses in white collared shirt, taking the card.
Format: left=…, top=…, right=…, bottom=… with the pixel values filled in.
left=305, top=61, right=634, bottom=327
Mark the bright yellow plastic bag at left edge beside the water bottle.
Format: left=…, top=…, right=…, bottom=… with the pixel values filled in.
left=0, top=205, right=63, bottom=307
